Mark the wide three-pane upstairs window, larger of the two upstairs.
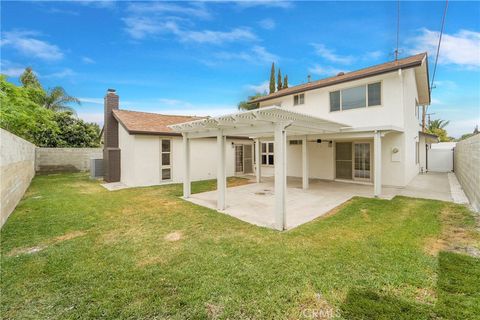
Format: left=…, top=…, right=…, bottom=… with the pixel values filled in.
left=330, top=82, right=382, bottom=111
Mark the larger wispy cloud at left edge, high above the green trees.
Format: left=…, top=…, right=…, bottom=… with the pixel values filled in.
left=0, top=31, right=63, bottom=61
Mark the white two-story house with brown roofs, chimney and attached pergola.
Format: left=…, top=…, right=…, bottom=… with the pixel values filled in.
left=104, top=53, right=433, bottom=229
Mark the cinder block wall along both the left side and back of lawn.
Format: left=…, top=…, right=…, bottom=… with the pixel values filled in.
left=0, top=129, right=102, bottom=227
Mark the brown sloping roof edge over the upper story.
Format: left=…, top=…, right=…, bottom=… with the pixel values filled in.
left=250, top=52, right=427, bottom=103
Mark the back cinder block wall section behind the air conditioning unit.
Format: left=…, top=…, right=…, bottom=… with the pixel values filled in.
left=35, top=148, right=103, bottom=173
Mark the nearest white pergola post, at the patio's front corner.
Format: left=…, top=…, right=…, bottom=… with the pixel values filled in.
left=274, top=123, right=287, bottom=230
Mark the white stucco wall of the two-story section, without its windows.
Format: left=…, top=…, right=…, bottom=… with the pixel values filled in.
left=260, top=69, right=425, bottom=186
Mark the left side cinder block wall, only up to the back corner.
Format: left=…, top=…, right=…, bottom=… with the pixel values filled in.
left=0, top=129, right=35, bottom=226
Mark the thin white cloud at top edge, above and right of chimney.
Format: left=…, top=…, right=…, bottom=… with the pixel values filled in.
left=127, top=2, right=211, bottom=19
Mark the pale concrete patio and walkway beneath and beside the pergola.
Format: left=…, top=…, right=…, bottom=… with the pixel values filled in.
left=188, top=173, right=468, bottom=229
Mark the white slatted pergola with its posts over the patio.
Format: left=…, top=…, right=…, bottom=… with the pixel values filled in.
left=169, top=106, right=381, bottom=230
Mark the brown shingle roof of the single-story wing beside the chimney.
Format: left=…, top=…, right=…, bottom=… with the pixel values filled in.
left=113, top=109, right=204, bottom=135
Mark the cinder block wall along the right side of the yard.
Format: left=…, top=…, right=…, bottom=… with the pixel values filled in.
left=454, top=134, right=480, bottom=212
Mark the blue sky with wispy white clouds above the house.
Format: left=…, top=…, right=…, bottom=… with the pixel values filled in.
left=1, top=1, right=480, bottom=136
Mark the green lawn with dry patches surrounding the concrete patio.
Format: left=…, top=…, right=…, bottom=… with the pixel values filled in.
left=0, top=174, right=480, bottom=319
